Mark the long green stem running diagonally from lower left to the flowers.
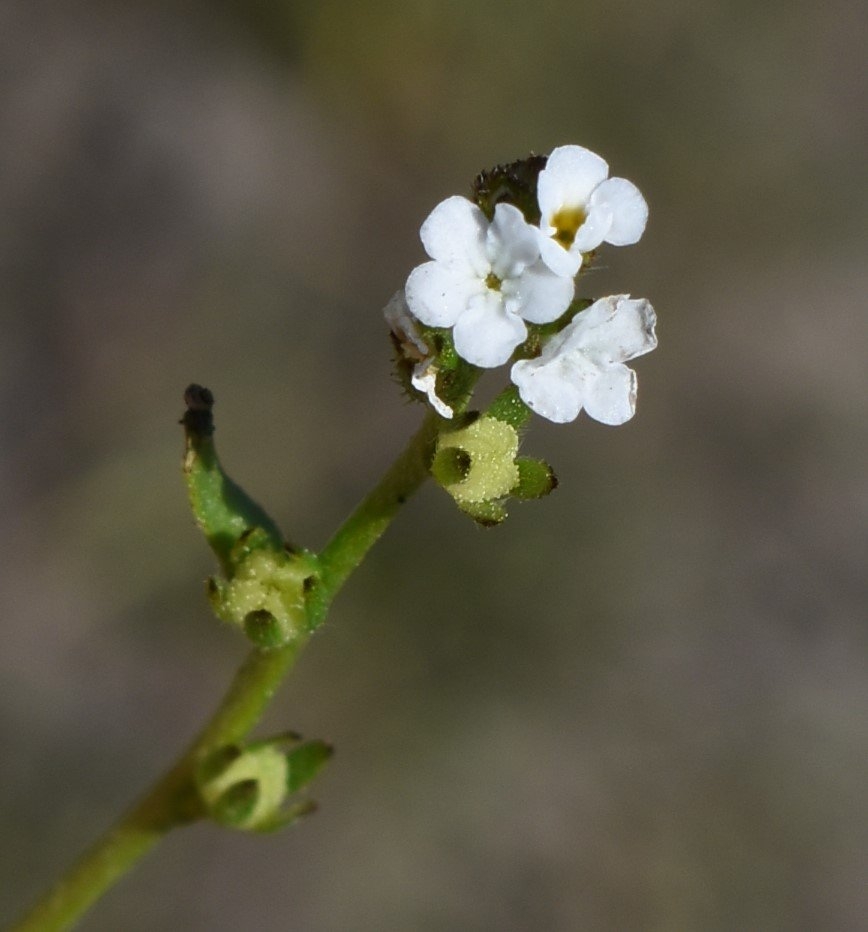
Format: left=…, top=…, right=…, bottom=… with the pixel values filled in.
left=10, top=415, right=437, bottom=932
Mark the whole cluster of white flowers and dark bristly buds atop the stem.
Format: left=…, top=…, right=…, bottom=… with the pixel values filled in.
left=386, top=146, right=657, bottom=424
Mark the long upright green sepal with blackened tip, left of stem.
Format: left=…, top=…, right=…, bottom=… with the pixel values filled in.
left=181, top=385, right=283, bottom=576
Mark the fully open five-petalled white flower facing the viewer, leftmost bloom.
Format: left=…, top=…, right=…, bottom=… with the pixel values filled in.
left=406, top=197, right=575, bottom=368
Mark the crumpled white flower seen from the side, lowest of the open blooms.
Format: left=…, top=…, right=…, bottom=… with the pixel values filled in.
left=511, top=295, right=657, bottom=425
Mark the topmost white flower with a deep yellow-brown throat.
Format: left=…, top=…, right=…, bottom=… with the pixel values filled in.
left=537, top=146, right=648, bottom=275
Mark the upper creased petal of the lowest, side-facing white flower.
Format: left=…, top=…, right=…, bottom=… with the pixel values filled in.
left=560, top=294, right=657, bottom=366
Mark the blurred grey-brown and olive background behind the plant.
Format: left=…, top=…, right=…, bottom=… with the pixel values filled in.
left=0, top=0, right=868, bottom=932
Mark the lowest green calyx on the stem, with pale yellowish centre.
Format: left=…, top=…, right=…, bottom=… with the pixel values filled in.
left=195, top=734, right=333, bottom=832
